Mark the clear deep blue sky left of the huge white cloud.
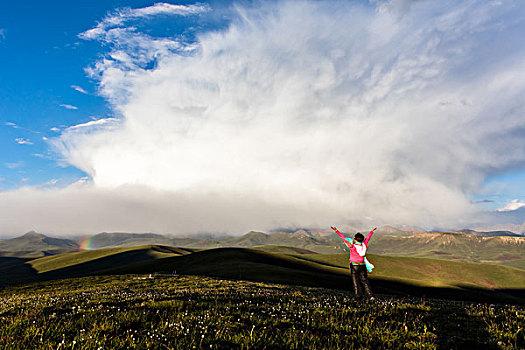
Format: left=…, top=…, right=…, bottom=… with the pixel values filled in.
left=0, top=1, right=229, bottom=190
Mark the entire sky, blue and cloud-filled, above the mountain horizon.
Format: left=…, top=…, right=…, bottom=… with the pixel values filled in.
left=0, top=0, right=525, bottom=237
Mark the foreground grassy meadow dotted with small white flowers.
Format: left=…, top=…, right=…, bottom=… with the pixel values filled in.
left=0, top=275, right=525, bottom=349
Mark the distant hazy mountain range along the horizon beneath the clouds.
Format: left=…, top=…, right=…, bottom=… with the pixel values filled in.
left=0, top=226, right=525, bottom=269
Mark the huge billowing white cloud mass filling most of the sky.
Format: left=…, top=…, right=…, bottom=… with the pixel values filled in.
left=1, top=1, right=525, bottom=232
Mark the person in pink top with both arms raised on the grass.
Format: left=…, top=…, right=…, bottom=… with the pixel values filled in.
left=330, top=226, right=377, bottom=298
